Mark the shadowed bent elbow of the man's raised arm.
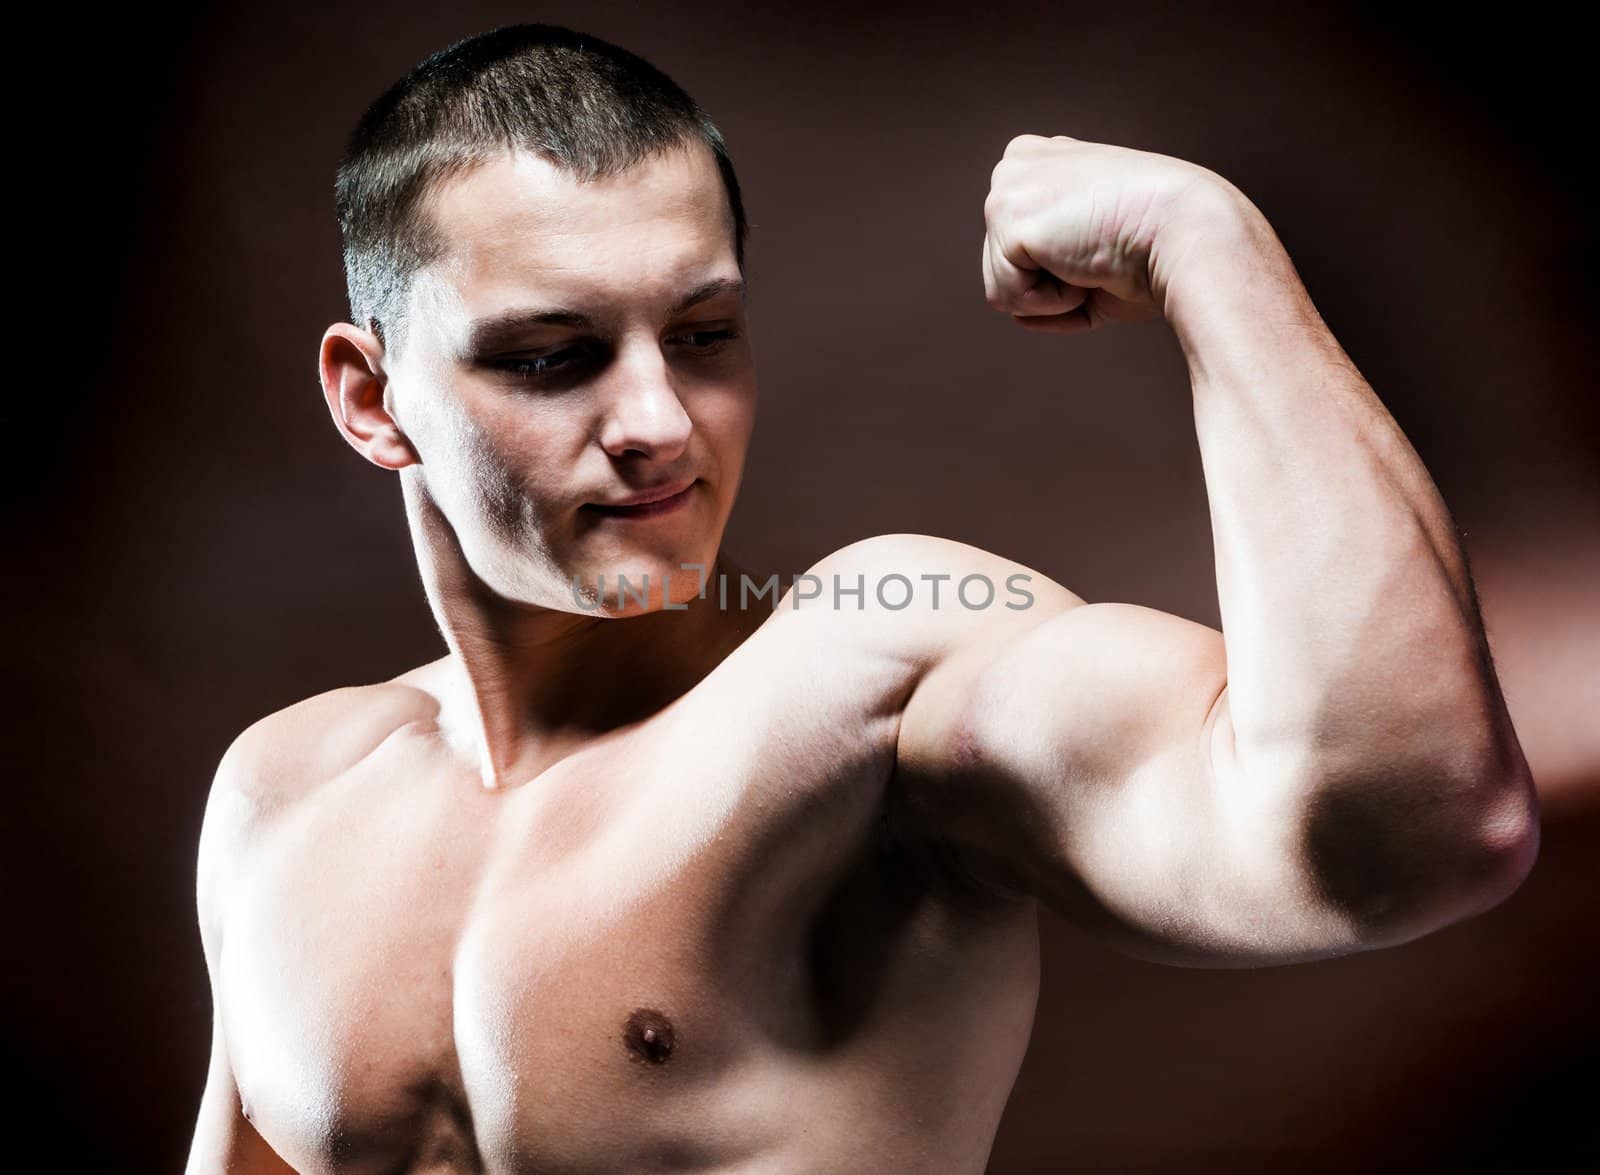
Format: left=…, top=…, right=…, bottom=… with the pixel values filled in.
left=1304, top=770, right=1539, bottom=946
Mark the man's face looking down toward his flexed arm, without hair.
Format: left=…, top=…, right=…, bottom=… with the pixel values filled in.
left=387, top=144, right=755, bottom=615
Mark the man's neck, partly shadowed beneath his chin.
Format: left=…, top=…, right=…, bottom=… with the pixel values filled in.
left=406, top=487, right=763, bottom=791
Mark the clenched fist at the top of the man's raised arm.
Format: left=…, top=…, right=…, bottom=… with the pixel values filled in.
left=982, top=134, right=1248, bottom=335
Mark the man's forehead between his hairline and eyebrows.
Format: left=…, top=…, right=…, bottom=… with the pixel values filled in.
left=418, top=142, right=738, bottom=333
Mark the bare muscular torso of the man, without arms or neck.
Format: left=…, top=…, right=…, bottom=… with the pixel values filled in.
left=219, top=592, right=1038, bottom=1175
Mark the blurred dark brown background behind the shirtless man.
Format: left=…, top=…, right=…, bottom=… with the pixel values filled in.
left=5, top=3, right=1600, bottom=1175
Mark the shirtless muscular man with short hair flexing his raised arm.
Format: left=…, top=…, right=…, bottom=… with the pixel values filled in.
left=189, top=27, right=1538, bottom=1175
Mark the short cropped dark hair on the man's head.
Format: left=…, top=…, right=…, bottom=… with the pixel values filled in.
left=334, top=24, right=747, bottom=352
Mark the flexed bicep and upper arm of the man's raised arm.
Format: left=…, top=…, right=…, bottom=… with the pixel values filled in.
left=898, top=604, right=1363, bottom=967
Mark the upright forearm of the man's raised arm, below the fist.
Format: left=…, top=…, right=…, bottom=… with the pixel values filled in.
left=1165, top=187, right=1533, bottom=915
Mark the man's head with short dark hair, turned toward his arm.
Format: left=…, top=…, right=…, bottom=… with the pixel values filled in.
left=322, top=26, right=755, bottom=615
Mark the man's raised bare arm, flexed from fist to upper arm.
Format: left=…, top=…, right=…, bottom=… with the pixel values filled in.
left=901, top=136, right=1538, bottom=965
